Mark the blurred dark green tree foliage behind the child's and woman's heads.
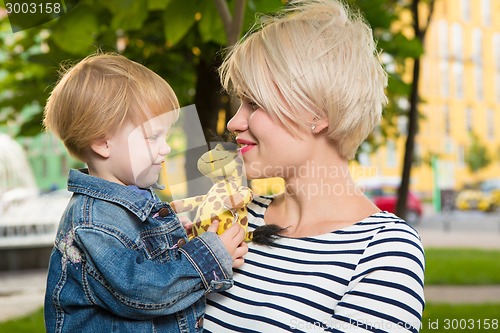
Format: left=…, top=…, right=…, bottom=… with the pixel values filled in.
left=0, top=0, right=422, bottom=151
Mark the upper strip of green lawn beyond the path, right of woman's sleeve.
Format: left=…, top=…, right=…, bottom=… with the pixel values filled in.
left=425, top=248, right=500, bottom=285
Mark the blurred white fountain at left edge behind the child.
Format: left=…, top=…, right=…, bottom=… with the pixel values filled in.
left=0, top=133, right=70, bottom=270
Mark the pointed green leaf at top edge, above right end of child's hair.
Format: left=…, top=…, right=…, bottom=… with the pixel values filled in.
left=163, top=0, right=197, bottom=46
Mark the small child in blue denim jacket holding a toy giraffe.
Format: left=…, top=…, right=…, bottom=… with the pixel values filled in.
left=44, top=54, right=247, bottom=333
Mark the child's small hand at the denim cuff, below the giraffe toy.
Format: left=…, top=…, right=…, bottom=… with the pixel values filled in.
left=207, top=221, right=248, bottom=268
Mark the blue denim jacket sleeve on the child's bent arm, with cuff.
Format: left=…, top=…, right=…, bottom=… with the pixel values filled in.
left=76, top=226, right=232, bottom=319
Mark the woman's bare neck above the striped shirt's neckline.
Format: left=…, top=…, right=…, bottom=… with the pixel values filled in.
left=265, top=162, right=379, bottom=237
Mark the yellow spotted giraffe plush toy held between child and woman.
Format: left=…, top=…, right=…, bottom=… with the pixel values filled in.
left=170, top=144, right=253, bottom=242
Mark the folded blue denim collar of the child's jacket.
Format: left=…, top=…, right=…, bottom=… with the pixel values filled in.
left=68, top=169, right=156, bottom=222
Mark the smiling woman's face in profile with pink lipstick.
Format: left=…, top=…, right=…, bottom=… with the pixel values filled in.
left=227, top=99, right=312, bottom=179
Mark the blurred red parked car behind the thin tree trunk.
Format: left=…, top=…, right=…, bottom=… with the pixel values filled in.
left=360, top=180, right=423, bottom=225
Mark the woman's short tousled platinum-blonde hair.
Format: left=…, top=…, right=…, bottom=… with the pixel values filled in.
left=219, top=0, right=387, bottom=159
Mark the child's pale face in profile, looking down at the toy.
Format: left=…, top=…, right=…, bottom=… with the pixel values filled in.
left=108, top=112, right=175, bottom=188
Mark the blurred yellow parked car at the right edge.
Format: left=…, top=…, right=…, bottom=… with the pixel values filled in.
left=455, top=179, right=500, bottom=212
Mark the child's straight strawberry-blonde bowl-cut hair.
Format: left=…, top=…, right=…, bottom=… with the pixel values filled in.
left=44, top=53, right=179, bottom=162
